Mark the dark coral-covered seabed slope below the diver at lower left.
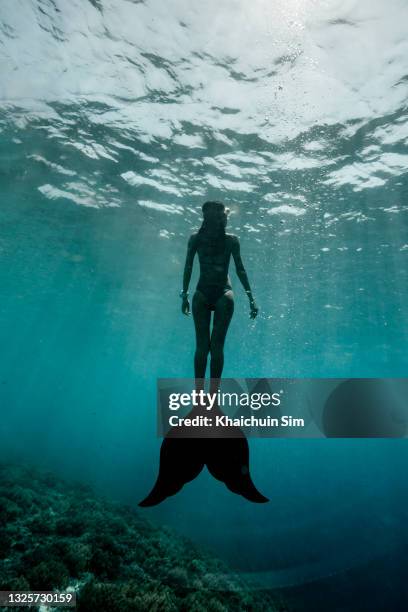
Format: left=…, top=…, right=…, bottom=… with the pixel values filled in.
left=0, top=464, right=286, bottom=612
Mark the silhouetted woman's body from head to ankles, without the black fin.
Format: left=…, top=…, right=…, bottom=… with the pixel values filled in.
left=180, top=202, right=258, bottom=390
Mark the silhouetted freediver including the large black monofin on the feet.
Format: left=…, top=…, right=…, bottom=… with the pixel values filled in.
left=139, top=202, right=268, bottom=506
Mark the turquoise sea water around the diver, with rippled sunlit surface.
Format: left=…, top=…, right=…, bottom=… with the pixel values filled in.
left=0, top=0, right=408, bottom=604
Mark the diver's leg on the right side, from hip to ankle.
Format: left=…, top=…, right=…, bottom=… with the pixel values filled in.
left=210, top=291, right=234, bottom=391
